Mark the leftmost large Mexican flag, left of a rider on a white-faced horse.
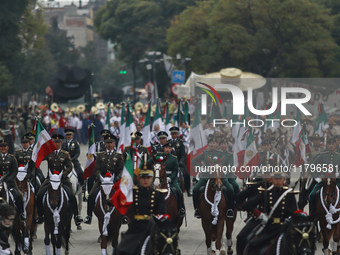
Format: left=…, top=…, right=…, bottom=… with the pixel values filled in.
left=32, top=120, right=57, bottom=168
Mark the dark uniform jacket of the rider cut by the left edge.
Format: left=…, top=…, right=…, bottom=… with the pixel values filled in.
left=0, top=153, right=18, bottom=187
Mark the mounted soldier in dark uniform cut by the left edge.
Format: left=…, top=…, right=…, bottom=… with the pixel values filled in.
left=0, top=139, right=27, bottom=221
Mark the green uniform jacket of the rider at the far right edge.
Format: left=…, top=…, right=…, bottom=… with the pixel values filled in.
left=307, top=149, right=340, bottom=178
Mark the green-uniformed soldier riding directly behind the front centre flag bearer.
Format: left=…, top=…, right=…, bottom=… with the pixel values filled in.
left=149, top=140, right=185, bottom=216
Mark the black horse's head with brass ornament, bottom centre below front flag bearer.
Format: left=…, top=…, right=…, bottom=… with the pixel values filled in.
left=151, top=216, right=180, bottom=255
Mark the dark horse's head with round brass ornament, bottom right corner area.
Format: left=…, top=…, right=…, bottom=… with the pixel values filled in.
left=284, top=212, right=318, bottom=255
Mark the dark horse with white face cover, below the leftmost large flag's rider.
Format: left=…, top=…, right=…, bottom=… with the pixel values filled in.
left=43, top=171, right=72, bottom=255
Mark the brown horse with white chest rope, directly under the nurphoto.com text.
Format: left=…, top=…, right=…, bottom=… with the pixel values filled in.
left=199, top=166, right=227, bottom=255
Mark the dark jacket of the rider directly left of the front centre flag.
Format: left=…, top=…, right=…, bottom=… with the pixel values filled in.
left=94, top=151, right=124, bottom=180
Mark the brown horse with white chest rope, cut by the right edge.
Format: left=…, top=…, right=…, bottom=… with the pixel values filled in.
left=316, top=178, right=340, bottom=254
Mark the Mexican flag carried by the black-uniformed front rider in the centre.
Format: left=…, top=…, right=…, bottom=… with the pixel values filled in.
left=111, top=155, right=133, bottom=215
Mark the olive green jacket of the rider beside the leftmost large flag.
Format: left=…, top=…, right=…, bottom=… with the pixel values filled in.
left=44, top=150, right=73, bottom=178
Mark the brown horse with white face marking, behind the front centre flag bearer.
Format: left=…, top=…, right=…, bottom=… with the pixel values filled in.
left=153, top=156, right=183, bottom=233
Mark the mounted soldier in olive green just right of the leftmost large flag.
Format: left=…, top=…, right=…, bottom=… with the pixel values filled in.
left=37, top=134, right=83, bottom=226
